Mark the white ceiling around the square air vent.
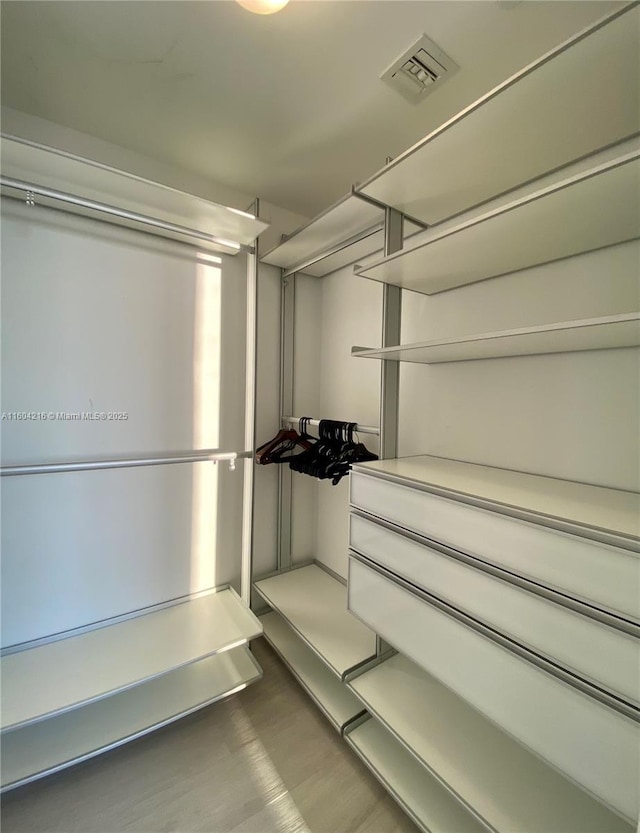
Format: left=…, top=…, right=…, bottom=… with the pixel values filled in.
left=2, top=0, right=626, bottom=216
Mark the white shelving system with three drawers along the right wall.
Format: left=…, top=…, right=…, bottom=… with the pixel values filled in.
left=257, top=4, right=640, bottom=833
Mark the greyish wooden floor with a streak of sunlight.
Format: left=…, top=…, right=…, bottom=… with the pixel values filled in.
left=1, top=639, right=416, bottom=833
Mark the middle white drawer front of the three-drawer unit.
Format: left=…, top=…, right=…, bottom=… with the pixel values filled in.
left=350, top=515, right=640, bottom=702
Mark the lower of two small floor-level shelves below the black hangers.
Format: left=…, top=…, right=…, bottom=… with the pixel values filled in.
left=260, top=611, right=364, bottom=732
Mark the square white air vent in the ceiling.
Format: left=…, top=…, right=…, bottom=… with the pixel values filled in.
left=380, top=35, right=458, bottom=104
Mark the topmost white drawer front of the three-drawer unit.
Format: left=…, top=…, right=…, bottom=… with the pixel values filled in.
left=350, top=472, right=640, bottom=619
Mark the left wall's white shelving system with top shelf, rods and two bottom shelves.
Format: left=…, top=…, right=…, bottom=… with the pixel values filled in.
left=0, top=137, right=268, bottom=790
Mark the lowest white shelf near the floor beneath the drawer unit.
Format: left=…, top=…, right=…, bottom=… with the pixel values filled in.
left=345, top=719, right=482, bottom=833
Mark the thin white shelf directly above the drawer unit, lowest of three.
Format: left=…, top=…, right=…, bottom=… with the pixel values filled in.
left=352, top=313, right=640, bottom=364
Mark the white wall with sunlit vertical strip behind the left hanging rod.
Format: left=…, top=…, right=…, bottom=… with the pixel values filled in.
left=0, top=199, right=251, bottom=644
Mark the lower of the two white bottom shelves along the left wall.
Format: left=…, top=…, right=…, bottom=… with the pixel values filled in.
left=2, top=647, right=262, bottom=790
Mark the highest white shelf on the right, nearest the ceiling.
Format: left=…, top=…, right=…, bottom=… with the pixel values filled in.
left=357, top=4, right=640, bottom=225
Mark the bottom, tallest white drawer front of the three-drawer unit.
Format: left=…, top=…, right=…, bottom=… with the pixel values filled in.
left=349, top=558, right=640, bottom=823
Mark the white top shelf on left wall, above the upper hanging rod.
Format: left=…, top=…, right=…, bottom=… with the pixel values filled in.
left=2, top=136, right=269, bottom=254
